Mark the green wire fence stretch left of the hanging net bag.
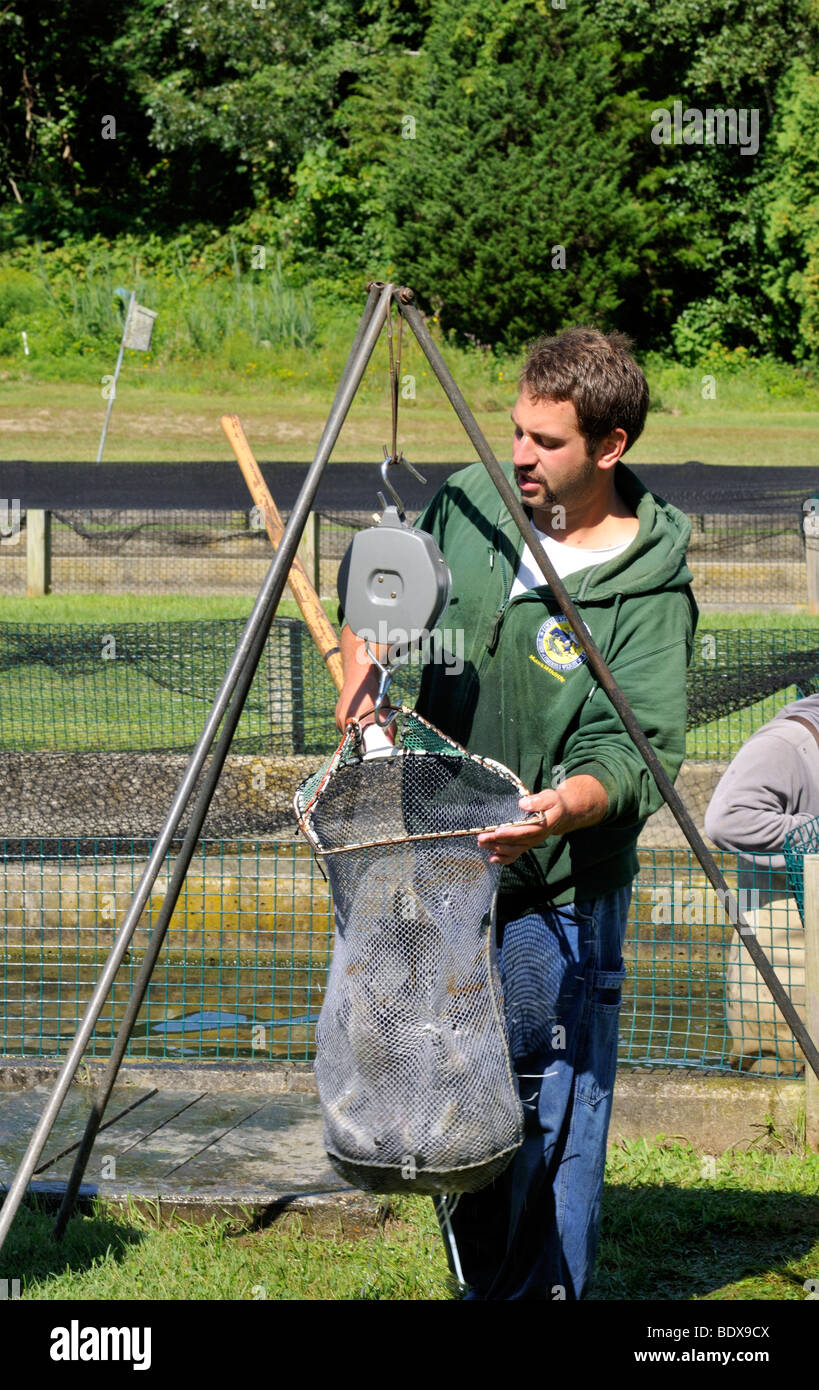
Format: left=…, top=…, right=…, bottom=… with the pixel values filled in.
left=0, top=840, right=331, bottom=1059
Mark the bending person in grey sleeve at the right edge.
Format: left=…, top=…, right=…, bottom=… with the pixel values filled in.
left=705, top=695, right=819, bottom=1073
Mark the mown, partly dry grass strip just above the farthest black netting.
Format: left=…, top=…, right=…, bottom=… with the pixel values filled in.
left=0, top=360, right=819, bottom=467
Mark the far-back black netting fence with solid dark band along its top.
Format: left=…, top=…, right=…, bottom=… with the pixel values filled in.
left=0, top=463, right=819, bottom=607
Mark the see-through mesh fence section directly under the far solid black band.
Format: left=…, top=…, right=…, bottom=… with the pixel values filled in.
left=0, top=509, right=815, bottom=607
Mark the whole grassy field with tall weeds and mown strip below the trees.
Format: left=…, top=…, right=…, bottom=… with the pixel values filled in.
left=0, top=244, right=819, bottom=466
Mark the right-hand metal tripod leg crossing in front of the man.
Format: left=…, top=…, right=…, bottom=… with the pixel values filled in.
left=395, top=289, right=819, bottom=1077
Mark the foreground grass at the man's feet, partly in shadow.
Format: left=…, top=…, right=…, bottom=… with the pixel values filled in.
left=0, top=1136, right=819, bottom=1301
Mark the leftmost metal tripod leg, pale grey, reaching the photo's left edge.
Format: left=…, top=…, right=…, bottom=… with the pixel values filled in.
left=0, top=285, right=394, bottom=1248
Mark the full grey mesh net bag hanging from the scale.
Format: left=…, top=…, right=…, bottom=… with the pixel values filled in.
left=295, top=710, right=526, bottom=1193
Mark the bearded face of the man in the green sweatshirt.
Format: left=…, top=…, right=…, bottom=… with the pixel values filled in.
left=512, top=392, right=605, bottom=530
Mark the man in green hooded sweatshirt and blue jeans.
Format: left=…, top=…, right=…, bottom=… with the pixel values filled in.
left=336, top=328, right=697, bottom=1300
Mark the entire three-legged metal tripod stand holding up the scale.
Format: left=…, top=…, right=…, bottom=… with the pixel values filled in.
left=0, top=282, right=819, bottom=1247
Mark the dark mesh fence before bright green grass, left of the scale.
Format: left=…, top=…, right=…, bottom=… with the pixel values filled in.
left=0, top=619, right=335, bottom=753
